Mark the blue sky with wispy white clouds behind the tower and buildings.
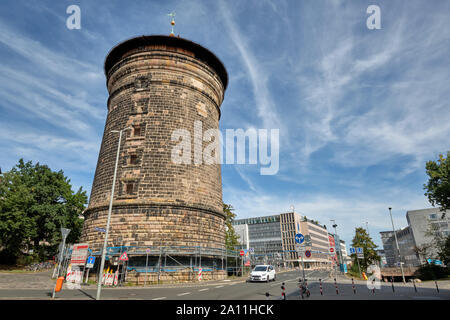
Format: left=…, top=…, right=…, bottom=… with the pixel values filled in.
left=0, top=0, right=450, bottom=245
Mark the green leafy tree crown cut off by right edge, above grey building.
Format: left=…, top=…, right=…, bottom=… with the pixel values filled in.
left=424, top=151, right=450, bottom=217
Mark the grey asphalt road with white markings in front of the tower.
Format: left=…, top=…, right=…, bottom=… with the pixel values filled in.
left=0, top=271, right=450, bottom=300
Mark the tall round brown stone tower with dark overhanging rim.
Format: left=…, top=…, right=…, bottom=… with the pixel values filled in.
left=81, top=35, right=228, bottom=258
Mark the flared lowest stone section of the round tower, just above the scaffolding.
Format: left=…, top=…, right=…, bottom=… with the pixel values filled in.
left=80, top=203, right=225, bottom=251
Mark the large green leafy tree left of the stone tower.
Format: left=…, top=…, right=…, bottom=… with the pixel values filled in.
left=0, top=159, right=87, bottom=264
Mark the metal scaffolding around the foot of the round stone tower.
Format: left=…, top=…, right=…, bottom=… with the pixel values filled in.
left=54, top=245, right=332, bottom=285
